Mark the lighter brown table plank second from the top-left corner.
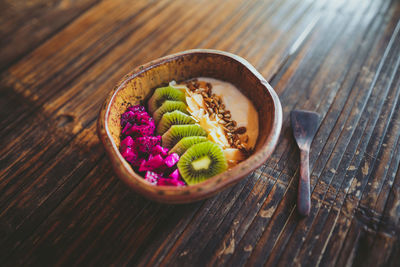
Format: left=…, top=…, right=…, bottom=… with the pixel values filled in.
left=0, top=1, right=170, bottom=136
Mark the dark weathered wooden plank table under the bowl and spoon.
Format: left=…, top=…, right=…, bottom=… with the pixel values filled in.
left=0, top=0, right=400, bottom=266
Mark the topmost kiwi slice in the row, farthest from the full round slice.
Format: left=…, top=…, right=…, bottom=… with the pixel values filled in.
left=147, top=86, right=186, bottom=113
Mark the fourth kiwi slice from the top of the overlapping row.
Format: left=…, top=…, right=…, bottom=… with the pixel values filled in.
left=162, top=124, right=207, bottom=148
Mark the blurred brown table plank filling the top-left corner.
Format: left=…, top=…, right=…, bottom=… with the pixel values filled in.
left=0, top=0, right=99, bottom=71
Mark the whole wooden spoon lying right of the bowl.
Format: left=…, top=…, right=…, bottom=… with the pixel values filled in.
left=290, top=110, right=319, bottom=216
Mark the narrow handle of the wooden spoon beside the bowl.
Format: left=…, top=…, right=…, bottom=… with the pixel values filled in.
left=297, top=149, right=311, bottom=216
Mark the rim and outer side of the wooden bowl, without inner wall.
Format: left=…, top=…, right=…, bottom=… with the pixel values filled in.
left=97, top=49, right=283, bottom=203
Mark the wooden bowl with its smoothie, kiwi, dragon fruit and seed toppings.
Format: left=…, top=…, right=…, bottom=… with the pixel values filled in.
left=97, top=49, right=282, bottom=203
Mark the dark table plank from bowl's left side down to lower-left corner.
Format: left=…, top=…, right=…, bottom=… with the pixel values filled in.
left=0, top=124, right=103, bottom=260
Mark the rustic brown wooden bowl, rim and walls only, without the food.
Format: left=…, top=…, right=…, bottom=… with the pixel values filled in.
left=97, top=49, right=282, bottom=203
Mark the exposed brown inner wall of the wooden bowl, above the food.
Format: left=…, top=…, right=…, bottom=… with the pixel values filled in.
left=107, top=53, right=274, bottom=152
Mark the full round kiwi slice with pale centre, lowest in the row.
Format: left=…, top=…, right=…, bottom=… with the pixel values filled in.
left=178, top=141, right=228, bottom=185
